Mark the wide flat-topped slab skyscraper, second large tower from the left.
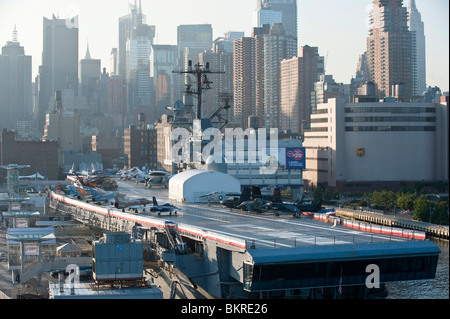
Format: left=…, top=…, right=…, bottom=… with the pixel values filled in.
left=38, top=15, right=78, bottom=130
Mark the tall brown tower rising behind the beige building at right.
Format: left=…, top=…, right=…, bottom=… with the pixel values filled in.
left=367, top=0, right=416, bottom=99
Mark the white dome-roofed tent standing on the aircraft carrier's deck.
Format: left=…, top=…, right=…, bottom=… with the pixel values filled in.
left=169, top=169, right=241, bottom=203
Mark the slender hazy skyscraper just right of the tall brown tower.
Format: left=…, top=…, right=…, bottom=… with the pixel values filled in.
left=408, top=0, right=427, bottom=95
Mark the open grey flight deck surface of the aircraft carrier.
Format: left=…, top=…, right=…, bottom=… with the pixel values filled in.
left=119, top=181, right=418, bottom=248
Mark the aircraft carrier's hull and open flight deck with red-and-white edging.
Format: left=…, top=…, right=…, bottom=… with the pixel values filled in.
left=49, top=181, right=440, bottom=299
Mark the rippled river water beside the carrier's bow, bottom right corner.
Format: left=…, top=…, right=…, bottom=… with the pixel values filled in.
left=386, top=240, right=449, bottom=299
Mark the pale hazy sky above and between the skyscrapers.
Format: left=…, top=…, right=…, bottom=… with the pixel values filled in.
left=0, top=0, right=449, bottom=91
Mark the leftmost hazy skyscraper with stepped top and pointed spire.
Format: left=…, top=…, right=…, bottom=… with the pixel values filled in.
left=0, top=28, right=33, bottom=129
